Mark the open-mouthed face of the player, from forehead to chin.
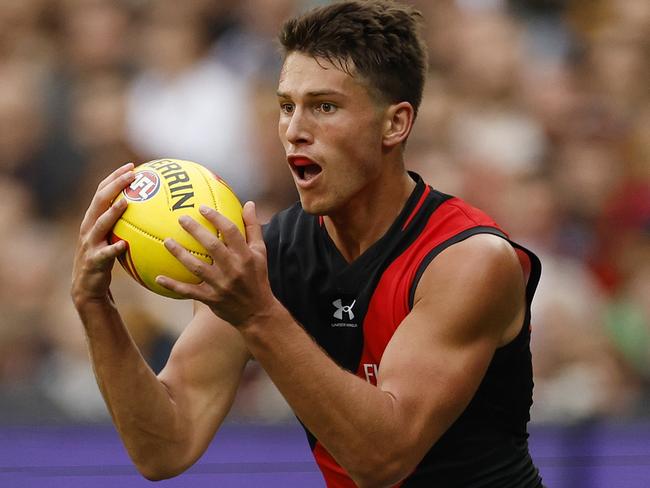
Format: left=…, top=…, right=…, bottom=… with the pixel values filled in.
left=278, top=52, right=385, bottom=215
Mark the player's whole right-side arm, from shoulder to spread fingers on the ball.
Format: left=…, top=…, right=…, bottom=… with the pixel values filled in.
left=160, top=207, right=524, bottom=486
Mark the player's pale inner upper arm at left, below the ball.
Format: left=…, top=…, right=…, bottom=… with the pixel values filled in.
left=158, top=304, right=250, bottom=457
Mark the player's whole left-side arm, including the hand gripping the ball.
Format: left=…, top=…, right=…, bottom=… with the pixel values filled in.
left=72, top=167, right=249, bottom=479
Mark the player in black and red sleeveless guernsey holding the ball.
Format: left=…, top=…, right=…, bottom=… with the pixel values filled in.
left=72, top=1, right=541, bottom=488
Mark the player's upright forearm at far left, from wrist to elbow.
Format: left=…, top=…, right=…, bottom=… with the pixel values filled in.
left=76, top=299, right=187, bottom=477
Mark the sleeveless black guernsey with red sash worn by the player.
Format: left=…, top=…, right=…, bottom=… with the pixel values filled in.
left=264, top=174, right=541, bottom=488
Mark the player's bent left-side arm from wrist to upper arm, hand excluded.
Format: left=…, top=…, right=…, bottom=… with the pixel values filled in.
left=80, top=303, right=249, bottom=479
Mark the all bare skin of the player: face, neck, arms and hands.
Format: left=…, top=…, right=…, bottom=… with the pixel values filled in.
left=72, top=53, right=525, bottom=487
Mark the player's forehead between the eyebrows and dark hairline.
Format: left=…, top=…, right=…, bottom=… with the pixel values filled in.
left=278, top=52, right=367, bottom=96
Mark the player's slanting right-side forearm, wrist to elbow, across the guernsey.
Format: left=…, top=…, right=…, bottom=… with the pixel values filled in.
left=241, top=302, right=404, bottom=482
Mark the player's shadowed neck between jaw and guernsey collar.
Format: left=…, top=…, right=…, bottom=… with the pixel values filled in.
left=323, top=171, right=415, bottom=262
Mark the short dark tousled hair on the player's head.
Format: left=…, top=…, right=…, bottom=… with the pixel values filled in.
left=279, top=0, right=427, bottom=113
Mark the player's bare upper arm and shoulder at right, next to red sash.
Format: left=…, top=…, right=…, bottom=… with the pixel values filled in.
left=378, top=236, right=524, bottom=457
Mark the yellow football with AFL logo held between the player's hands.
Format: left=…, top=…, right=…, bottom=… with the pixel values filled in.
left=110, top=159, right=246, bottom=298
